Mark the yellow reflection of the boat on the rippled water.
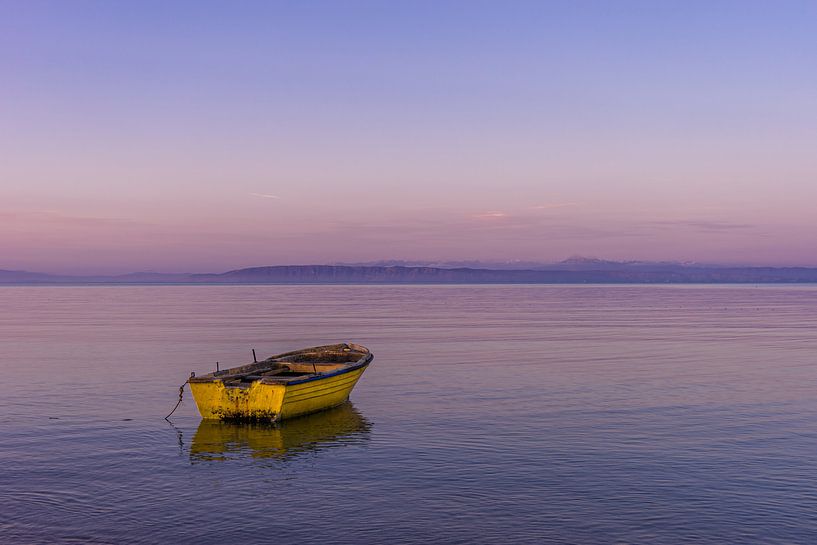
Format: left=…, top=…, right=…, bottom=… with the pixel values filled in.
left=190, top=402, right=371, bottom=463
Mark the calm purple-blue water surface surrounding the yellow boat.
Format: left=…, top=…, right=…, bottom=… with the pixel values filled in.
left=0, top=286, right=817, bottom=544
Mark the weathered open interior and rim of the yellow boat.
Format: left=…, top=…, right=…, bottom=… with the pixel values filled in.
left=190, top=343, right=371, bottom=388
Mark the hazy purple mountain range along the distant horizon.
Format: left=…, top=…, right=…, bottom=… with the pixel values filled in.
left=0, top=259, right=817, bottom=285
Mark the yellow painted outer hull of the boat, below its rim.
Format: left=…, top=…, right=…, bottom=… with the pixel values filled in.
left=190, top=363, right=368, bottom=422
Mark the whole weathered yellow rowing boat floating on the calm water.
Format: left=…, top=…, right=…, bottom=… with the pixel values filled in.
left=188, top=343, right=374, bottom=422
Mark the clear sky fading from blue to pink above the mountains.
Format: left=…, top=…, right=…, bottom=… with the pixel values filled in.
left=0, top=0, right=817, bottom=274
